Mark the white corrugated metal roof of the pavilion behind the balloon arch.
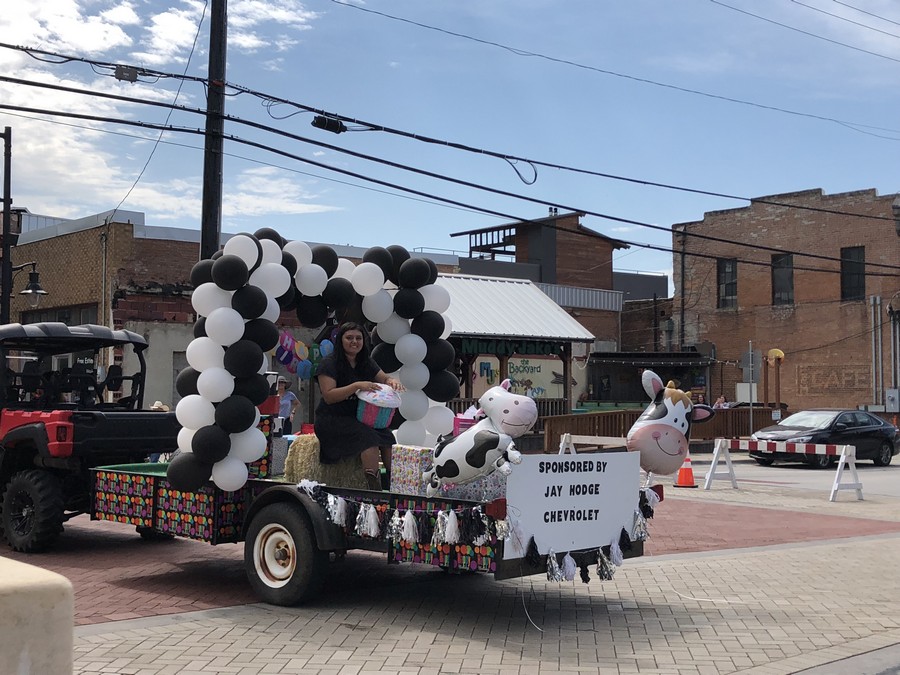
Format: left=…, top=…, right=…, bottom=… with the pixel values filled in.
left=435, top=274, right=594, bottom=342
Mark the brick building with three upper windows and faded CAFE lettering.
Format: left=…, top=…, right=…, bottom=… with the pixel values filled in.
left=672, top=190, right=900, bottom=410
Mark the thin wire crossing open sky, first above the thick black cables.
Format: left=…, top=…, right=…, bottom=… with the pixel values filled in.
left=330, top=0, right=900, bottom=140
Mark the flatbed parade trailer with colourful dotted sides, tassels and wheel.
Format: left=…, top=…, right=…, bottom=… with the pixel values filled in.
left=91, top=453, right=643, bottom=605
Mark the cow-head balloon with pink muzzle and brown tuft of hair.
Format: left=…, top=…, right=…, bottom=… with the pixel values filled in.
left=625, top=370, right=715, bottom=475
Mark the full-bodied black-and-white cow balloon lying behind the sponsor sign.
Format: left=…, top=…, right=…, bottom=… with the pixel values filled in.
left=422, top=380, right=537, bottom=497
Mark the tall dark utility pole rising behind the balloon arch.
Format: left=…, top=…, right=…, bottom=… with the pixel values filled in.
left=200, top=0, right=228, bottom=260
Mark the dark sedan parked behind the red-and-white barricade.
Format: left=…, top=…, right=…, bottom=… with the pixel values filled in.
left=750, top=409, right=900, bottom=469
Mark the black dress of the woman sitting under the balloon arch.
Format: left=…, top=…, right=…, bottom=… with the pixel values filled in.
left=315, top=356, right=394, bottom=464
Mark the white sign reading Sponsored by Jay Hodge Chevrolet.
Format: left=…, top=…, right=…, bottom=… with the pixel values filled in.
left=503, top=452, right=641, bottom=559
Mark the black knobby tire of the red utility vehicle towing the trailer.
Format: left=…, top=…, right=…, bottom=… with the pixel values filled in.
left=2, top=469, right=63, bottom=553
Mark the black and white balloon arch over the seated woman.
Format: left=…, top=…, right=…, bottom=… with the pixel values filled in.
left=167, top=228, right=459, bottom=491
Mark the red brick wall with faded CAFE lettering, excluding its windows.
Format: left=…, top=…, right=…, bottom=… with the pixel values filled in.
left=673, top=190, right=900, bottom=409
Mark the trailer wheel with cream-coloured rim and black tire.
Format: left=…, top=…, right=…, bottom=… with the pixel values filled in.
left=244, top=503, right=328, bottom=606
